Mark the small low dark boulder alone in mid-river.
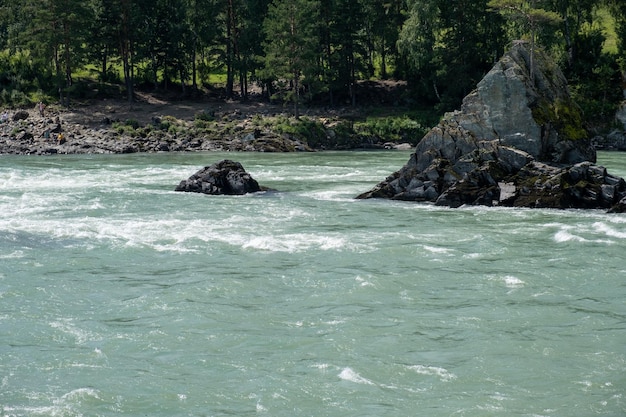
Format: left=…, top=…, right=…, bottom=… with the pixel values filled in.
left=175, top=159, right=267, bottom=195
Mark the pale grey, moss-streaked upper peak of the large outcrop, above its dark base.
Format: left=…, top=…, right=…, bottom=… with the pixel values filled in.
left=416, top=46, right=596, bottom=170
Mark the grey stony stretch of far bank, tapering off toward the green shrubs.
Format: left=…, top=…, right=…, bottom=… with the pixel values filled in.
left=0, top=103, right=312, bottom=155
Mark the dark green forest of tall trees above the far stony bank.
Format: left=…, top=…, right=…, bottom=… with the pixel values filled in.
left=0, top=0, right=626, bottom=130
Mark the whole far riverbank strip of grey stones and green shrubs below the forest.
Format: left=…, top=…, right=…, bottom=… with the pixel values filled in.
left=0, top=82, right=439, bottom=155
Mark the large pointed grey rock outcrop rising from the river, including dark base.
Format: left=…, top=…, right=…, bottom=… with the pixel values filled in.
left=357, top=44, right=626, bottom=210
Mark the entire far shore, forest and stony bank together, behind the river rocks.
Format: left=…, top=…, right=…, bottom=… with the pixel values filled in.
left=0, top=0, right=626, bottom=154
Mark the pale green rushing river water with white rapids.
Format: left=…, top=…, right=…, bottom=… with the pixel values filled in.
left=0, top=152, right=626, bottom=417
